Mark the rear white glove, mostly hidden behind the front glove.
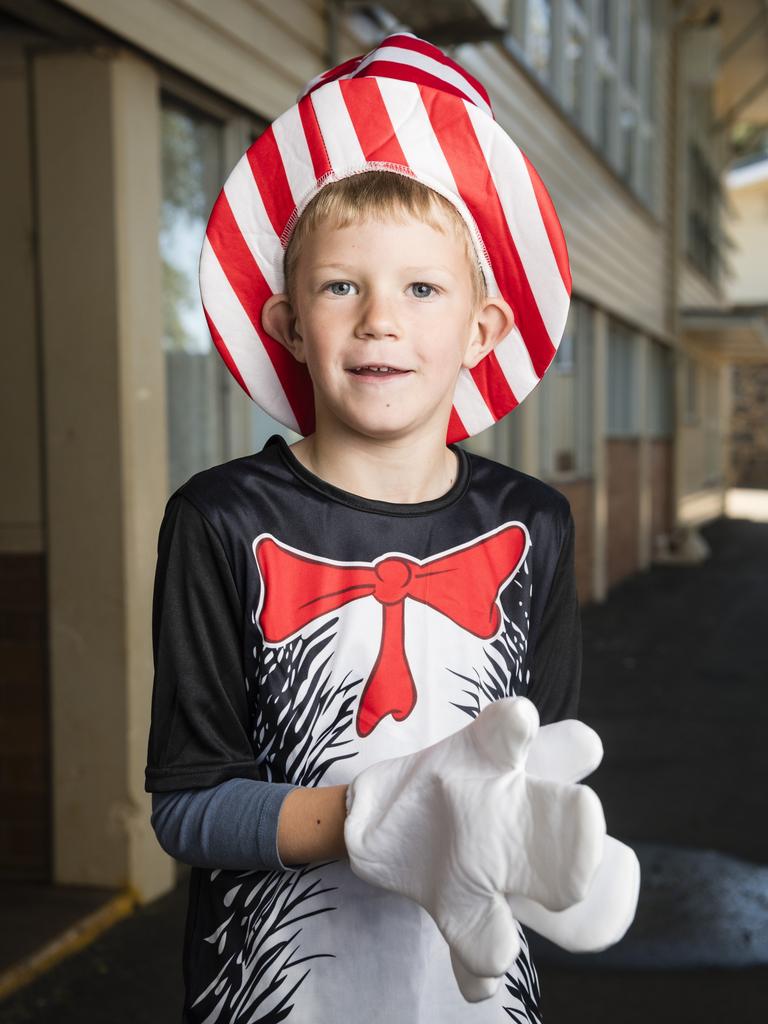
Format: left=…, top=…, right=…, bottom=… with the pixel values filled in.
left=451, top=719, right=640, bottom=1002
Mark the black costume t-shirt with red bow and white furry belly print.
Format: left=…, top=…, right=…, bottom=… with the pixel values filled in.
left=145, top=434, right=582, bottom=1024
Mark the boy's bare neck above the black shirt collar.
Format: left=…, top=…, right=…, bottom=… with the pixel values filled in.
left=289, top=431, right=459, bottom=505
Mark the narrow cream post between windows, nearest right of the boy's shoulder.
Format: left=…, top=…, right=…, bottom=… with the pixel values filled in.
left=592, top=308, right=608, bottom=601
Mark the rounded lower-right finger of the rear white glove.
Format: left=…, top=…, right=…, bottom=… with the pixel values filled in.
left=509, top=836, right=640, bottom=953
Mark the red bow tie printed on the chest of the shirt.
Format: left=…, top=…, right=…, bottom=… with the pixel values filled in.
left=254, top=523, right=528, bottom=736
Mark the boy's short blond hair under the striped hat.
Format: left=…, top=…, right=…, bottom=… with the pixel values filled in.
left=284, top=170, right=487, bottom=309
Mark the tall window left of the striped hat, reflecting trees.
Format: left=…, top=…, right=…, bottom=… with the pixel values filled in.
left=160, top=95, right=227, bottom=490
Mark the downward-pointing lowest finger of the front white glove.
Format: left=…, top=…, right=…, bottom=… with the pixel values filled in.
left=437, top=893, right=520, bottom=977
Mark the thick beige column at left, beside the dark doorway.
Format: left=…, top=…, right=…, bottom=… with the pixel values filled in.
left=33, top=48, right=175, bottom=899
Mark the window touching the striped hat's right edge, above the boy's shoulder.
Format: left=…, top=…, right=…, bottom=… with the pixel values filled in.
left=538, top=299, right=593, bottom=477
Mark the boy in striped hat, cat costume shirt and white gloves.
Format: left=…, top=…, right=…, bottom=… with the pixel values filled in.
left=146, top=35, right=636, bottom=1024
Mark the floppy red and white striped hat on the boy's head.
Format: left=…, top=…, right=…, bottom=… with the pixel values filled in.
left=200, top=33, right=571, bottom=443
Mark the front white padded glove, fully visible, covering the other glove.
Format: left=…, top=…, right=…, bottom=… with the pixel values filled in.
left=344, top=696, right=605, bottom=997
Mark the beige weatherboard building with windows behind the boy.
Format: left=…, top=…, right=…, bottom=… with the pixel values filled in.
left=0, top=0, right=768, bottom=925
